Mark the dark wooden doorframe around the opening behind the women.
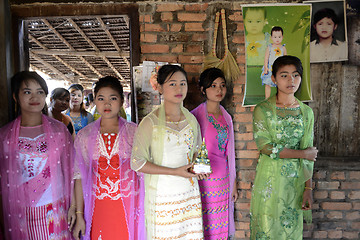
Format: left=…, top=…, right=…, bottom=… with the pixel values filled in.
left=11, top=3, right=140, bottom=122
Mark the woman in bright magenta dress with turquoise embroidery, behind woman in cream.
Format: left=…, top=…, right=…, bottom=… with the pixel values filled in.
left=191, top=68, right=238, bottom=240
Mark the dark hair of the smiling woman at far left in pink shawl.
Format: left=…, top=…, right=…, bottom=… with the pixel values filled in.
left=11, top=71, right=49, bottom=114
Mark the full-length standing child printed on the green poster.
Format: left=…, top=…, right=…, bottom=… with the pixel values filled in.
left=260, top=26, right=286, bottom=98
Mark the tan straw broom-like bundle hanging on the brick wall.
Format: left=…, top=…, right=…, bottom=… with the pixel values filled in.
left=203, top=9, right=241, bottom=82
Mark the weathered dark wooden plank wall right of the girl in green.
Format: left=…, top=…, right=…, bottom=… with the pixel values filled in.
left=309, top=63, right=360, bottom=157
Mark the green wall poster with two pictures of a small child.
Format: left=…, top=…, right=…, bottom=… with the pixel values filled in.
left=242, top=4, right=311, bottom=106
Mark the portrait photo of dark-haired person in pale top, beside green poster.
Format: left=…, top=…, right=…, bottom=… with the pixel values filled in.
left=306, top=0, right=348, bottom=62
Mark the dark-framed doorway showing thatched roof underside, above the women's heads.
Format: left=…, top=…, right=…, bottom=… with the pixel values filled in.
left=11, top=3, right=140, bottom=122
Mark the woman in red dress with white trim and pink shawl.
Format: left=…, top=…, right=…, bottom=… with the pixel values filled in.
left=73, top=77, right=145, bottom=240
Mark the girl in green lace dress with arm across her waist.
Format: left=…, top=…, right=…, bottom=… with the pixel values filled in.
left=250, top=56, right=317, bottom=240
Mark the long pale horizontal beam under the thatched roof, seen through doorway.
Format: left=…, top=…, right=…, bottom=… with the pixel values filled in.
left=31, top=49, right=129, bottom=58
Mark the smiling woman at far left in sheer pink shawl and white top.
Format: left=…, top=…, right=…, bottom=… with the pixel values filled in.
left=0, top=71, right=73, bottom=240
